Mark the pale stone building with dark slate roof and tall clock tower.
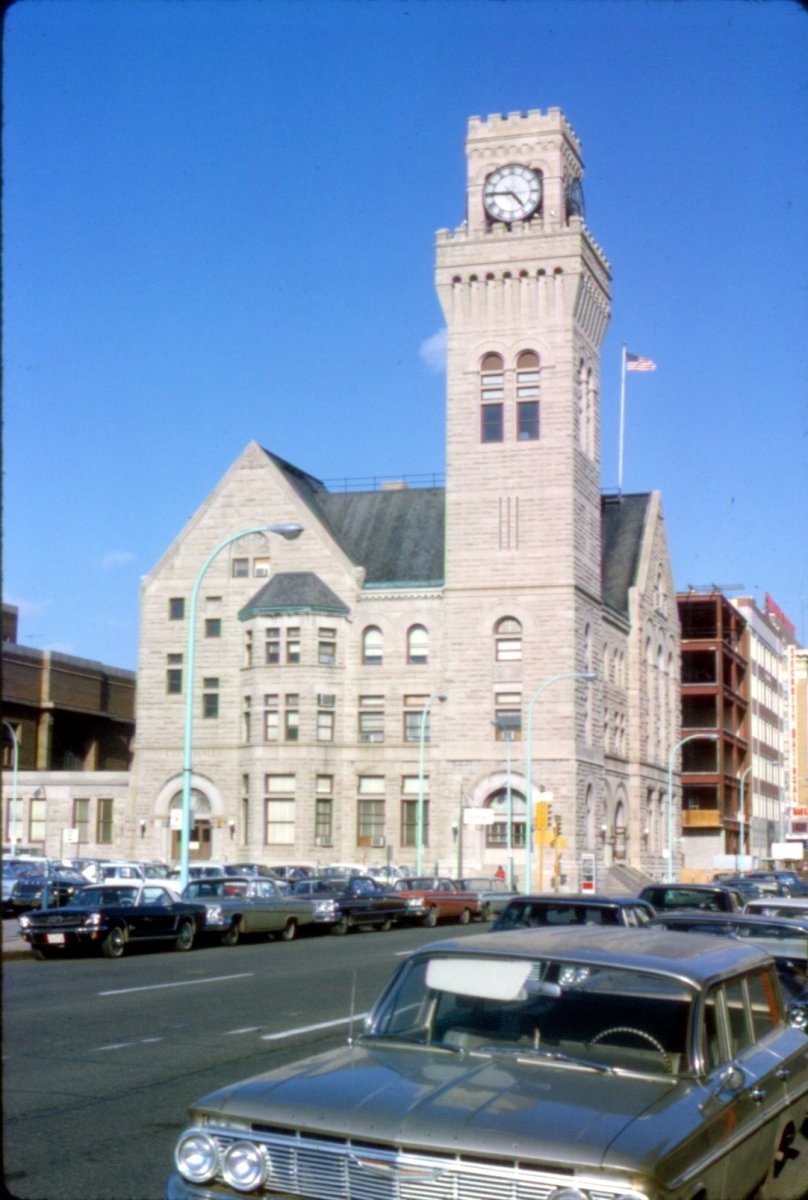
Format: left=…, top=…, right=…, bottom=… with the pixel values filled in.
left=131, top=109, right=680, bottom=886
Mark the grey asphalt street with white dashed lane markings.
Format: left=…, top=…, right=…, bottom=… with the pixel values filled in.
left=2, top=922, right=487, bottom=1200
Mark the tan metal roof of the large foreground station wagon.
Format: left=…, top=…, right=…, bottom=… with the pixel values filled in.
left=415, top=925, right=772, bottom=988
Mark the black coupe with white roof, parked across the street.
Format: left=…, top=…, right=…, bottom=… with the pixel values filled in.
left=19, top=880, right=205, bottom=959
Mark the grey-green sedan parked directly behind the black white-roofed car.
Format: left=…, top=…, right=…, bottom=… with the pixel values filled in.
left=182, top=875, right=319, bottom=946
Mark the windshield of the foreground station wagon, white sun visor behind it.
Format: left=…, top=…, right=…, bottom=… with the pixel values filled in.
left=364, top=954, right=695, bottom=1075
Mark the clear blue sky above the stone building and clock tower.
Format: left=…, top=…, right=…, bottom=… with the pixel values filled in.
left=2, top=0, right=808, bottom=668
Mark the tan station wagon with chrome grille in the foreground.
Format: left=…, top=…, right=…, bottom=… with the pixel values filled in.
left=166, top=928, right=808, bottom=1200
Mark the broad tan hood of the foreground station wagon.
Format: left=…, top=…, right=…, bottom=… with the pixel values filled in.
left=192, top=1044, right=688, bottom=1168
